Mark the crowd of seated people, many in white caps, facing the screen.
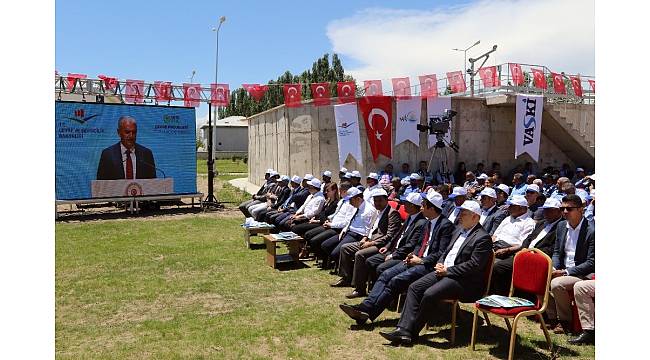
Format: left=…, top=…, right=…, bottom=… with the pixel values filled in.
left=239, top=161, right=595, bottom=344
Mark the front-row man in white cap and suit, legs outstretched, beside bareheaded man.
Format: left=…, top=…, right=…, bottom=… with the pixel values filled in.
left=340, top=191, right=454, bottom=324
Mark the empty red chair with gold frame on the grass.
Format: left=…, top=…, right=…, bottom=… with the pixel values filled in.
left=470, top=249, right=553, bottom=360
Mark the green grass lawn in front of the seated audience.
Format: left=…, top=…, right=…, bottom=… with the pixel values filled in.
left=55, top=213, right=594, bottom=359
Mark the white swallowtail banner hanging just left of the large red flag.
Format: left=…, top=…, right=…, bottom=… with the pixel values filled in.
left=334, top=101, right=363, bottom=167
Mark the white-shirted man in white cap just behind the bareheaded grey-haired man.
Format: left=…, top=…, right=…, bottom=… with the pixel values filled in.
left=492, top=195, right=535, bottom=251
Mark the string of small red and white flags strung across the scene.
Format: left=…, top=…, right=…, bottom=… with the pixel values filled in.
left=56, top=63, right=596, bottom=107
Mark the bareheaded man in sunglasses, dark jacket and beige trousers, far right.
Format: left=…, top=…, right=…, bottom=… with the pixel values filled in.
left=546, top=194, right=596, bottom=333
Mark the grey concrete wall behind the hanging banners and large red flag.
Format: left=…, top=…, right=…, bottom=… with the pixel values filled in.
left=248, top=97, right=588, bottom=184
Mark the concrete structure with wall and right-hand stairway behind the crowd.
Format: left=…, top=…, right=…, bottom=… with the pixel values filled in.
left=248, top=95, right=595, bottom=184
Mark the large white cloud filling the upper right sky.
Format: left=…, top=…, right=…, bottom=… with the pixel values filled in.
left=327, top=0, right=595, bottom=87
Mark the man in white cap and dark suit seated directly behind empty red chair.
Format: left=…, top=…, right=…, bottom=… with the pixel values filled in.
left=490, top=198, right=562, bottom=296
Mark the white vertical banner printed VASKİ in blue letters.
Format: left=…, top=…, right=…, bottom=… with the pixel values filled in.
left=515, top=95, right=544, bottom=162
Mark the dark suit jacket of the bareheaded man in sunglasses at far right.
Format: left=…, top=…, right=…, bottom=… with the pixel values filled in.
left=553, top=219, right=596, bottom=278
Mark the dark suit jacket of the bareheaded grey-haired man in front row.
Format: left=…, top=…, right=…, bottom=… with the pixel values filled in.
left=438, top=224, right=492, bottom=302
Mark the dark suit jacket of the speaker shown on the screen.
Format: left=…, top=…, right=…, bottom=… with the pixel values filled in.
left=97, top=142, right=156, bottom=180
